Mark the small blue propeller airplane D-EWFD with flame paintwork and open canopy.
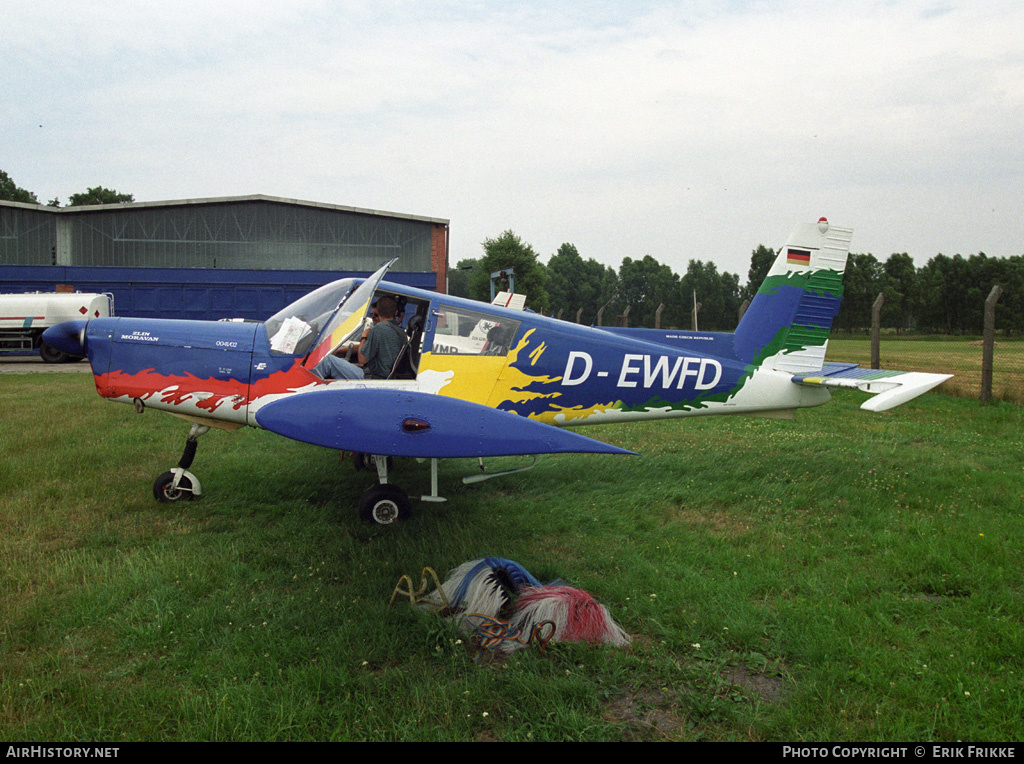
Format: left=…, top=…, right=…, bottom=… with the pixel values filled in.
left=44, top=218, right=950, bottom=524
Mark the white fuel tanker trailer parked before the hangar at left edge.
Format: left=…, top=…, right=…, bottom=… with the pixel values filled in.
left=0, top=292, right=114, bottom=364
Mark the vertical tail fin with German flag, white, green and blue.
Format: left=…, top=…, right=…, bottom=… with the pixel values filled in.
left=733, top=218, right=853, bottom=374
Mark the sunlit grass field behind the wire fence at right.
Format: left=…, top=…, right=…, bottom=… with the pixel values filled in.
left=827, top=335, right=1024, bottom=404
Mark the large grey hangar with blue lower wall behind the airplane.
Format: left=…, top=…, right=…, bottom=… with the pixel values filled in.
left=0, top=197, right=449, bottom=321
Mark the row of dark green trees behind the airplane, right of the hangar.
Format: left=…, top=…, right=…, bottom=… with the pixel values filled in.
left=449, top=230, right=1024, bottom=335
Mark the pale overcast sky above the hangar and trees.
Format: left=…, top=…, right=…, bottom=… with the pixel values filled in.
left=0, top=0, right=1024, bottom=282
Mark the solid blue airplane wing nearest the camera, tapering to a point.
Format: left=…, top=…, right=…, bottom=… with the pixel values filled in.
left=256, top=386, right=634, bottom=459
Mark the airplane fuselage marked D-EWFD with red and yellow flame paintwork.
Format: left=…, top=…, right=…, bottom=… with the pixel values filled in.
left=70, top=283, right=828, bottom=438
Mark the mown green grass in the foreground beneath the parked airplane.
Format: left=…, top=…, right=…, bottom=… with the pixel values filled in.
left=0, top=374, right=1024, bottom=742
